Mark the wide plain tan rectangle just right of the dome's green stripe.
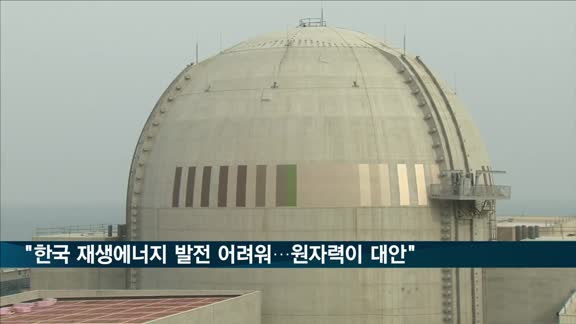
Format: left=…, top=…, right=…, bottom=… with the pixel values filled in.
left=297, top=163, right=359, bottom=207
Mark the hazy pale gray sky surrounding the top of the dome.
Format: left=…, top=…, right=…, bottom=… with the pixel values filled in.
left=1, top=1, right=576, bottom=217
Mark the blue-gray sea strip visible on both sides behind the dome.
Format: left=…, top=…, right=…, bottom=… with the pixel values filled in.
left=0, top=200, right=576, bottom=241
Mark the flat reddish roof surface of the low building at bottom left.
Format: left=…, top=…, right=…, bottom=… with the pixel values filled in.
left=0, top=296, right=234, bottom=324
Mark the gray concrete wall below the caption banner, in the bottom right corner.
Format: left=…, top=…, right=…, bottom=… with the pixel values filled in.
left=486, top=268, right=576, bottom=324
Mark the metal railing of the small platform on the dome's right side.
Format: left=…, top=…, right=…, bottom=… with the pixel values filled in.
left=430, top=184, right=511, bottom=200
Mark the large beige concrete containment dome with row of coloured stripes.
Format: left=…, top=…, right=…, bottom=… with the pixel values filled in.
left=127, top=26, right=498, bottom=324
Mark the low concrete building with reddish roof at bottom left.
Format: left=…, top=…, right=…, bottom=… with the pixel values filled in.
left=0, top=289, right=261, bottom=324
